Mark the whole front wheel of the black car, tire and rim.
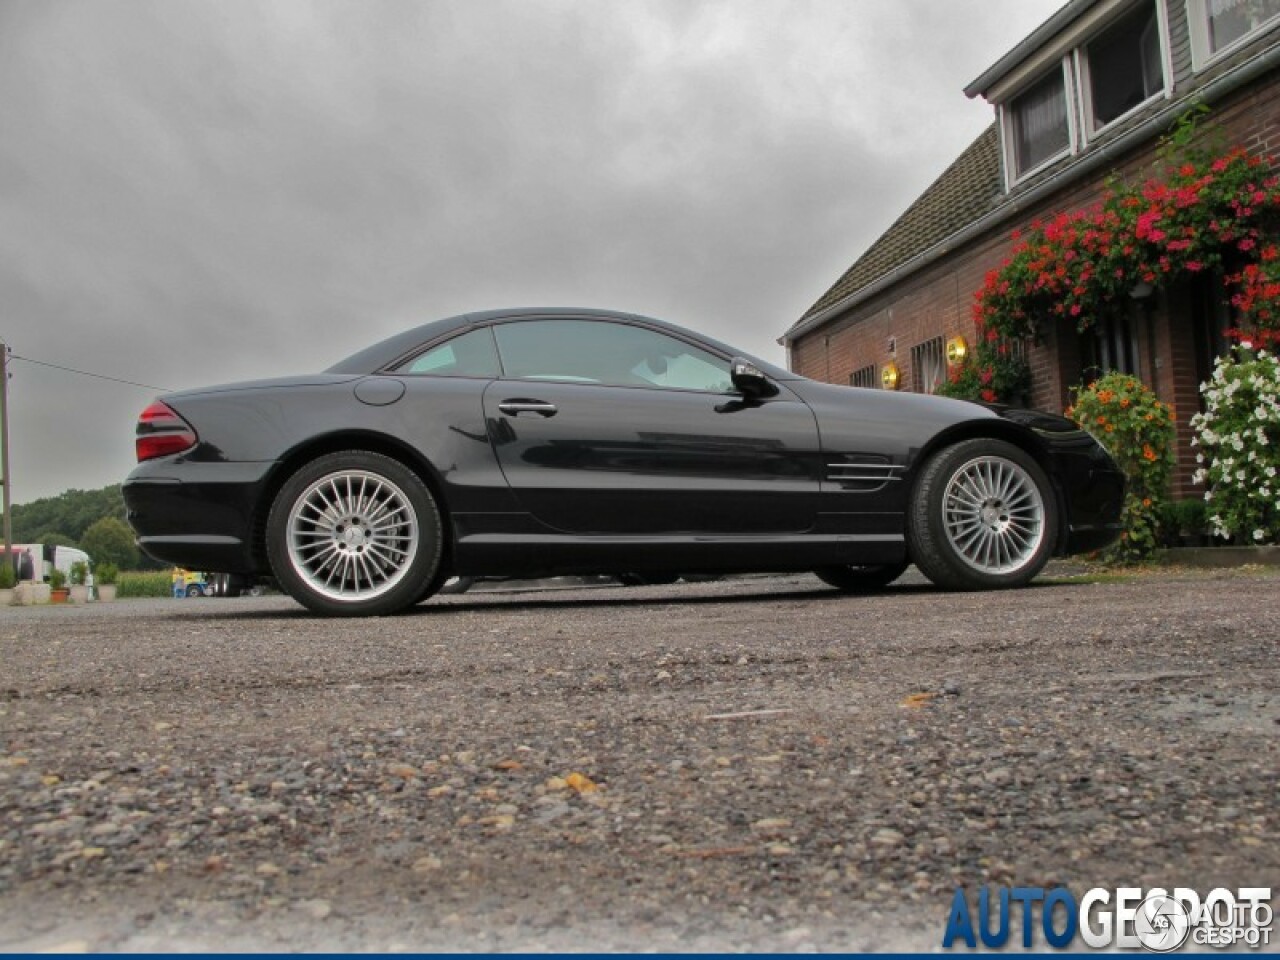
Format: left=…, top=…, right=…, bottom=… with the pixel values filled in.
left=906, top=439, right=1059, bottom=590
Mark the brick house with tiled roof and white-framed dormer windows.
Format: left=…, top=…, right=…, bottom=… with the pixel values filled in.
left=780, top=0, right=1280, bottom=497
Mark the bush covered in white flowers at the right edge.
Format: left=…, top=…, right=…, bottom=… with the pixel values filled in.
left=1192, top=347, right=1280, bottom=544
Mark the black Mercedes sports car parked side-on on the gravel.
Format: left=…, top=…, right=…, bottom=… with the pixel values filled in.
left=124, top=310, right=1124, bottom=616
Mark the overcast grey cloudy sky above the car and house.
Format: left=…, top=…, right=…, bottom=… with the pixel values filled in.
left=0, top=0, right=1060, bottom=503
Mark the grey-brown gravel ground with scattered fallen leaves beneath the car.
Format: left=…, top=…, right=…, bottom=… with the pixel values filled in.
left=0, top=567, right=1280, bottom=951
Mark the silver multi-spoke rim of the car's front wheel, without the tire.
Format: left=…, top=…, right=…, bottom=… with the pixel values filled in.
left=942, top=456, right=1044, bottom=575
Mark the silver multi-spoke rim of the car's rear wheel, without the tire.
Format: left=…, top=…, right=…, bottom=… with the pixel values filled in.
left=288, top=470, right=419, bottom=602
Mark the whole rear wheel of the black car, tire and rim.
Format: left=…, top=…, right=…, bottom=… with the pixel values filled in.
left=266, top=451, right=442, bottom=617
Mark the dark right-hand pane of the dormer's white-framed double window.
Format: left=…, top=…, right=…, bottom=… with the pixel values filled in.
left=1080, top=0, right=1167, bottom=132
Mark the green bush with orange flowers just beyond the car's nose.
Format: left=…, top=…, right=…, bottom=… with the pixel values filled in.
left=1066, top=374, right=1174, bottom=563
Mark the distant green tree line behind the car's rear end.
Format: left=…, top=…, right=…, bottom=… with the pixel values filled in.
left=0, top=484, right=164, bottom=570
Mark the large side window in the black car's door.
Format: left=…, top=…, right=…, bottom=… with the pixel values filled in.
left=494, top=320, right=733, bottom=393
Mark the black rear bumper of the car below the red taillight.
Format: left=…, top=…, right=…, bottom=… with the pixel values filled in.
left=123, top=458, right=275, bottom=573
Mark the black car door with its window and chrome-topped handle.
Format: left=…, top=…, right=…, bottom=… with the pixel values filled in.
left=484, top=317, right=820, bottom=535
